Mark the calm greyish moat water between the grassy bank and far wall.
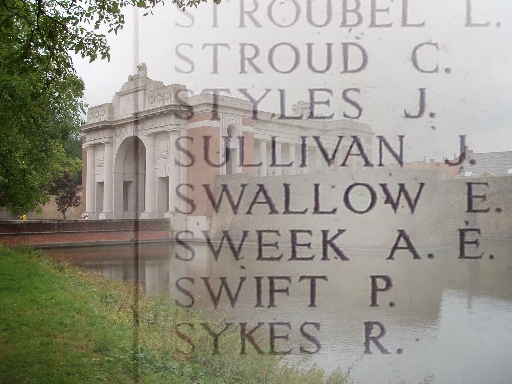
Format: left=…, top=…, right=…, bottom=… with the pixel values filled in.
left=55, top=240, right=512, bottom=383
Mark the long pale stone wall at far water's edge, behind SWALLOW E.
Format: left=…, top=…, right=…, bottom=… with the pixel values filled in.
left=208, top=169, right=512, bottom=255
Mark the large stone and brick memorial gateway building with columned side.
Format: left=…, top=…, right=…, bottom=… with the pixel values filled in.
left=82, top=64, right=373, bottom=231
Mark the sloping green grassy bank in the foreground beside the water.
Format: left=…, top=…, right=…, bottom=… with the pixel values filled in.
left=0, top=247, right=351, bottom=384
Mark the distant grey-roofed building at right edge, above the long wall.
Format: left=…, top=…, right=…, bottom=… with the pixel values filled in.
left=457, top=149, right=512, bottom=178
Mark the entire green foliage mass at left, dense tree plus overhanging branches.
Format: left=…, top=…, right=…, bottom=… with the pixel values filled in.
left=0, top=0, right=220, bottom=214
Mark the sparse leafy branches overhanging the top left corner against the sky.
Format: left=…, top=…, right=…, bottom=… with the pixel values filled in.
left=0, top=0, right=220, bottom=68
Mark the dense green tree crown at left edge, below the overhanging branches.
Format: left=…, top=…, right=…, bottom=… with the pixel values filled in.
left=0, top=42, right=83, bottom=213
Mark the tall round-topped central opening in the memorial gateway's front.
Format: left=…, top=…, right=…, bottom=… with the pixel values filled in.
left=114, top=136, right=146, bottom=219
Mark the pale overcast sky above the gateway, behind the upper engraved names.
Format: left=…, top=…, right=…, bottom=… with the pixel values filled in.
left=75, top=0, right=512, bottom=161
